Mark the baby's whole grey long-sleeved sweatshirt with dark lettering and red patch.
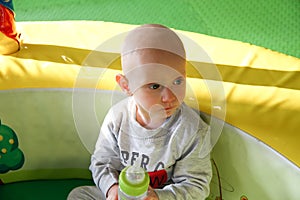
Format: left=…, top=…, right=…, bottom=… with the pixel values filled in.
left=90, top=97, right=212, bottom=200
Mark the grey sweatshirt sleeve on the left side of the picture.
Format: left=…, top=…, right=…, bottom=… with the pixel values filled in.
left=89, top=111, right=121, bottom=195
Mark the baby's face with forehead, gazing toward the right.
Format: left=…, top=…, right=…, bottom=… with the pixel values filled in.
left=122, top=49, right=186, bottom=119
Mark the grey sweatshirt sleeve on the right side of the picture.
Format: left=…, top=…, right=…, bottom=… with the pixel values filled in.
left=155, top=127, right=212, bottom=200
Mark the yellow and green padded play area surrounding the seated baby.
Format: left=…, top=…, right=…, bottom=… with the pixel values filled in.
left=0, top=0, right=300, bottom=200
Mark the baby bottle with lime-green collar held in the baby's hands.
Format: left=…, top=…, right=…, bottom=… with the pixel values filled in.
left=118, top=166, right=150, bottom=200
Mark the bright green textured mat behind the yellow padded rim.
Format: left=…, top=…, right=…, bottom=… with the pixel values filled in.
left=14, top=0, right=300, bottom=58
